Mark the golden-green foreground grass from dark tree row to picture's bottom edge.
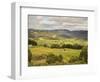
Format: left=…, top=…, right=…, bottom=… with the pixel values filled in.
left=29, top=46, right=81, bottom=66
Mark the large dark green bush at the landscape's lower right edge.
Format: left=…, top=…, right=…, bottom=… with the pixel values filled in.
left=79, top=46, right=88, bottom=63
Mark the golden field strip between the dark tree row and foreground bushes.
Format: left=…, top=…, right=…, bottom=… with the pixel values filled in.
left=30, top=46, right=80, bottom=56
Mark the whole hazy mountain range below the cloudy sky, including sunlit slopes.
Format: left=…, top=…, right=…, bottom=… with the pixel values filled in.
left=28, top=29, right=88, bottom=39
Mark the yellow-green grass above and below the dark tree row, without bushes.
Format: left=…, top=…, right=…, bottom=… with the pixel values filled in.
left=29, top=37, right=87, bottom=66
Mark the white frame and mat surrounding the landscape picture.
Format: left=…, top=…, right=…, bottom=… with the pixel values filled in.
left=12, top=3, right=95, bottom=79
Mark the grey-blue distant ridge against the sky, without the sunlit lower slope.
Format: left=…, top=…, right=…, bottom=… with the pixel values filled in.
left=28, top=29, right=88, bottom=39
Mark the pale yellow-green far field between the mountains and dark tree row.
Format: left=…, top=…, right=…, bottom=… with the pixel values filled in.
left=36, top=38, right=87, bottom=46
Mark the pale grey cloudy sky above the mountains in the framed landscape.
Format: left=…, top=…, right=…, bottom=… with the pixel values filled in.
left=28, top=15, right=88, bottom=30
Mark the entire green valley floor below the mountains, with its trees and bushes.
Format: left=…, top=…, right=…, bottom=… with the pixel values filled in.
left=28, top=37, right=87, bottom=66
